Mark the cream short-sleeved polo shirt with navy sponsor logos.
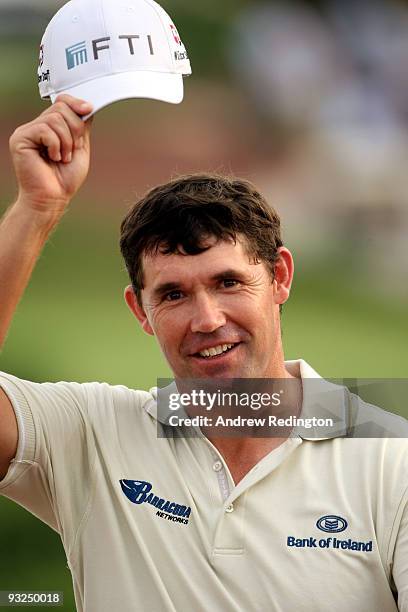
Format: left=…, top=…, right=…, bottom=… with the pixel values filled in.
left=0, top=361, right=408, bottom=612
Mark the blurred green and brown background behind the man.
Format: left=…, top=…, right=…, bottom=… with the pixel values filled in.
left=0, top=0, right=408, bottom=610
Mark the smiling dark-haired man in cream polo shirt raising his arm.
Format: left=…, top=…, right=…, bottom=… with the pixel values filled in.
left=0, top=96, right=408, bottom=612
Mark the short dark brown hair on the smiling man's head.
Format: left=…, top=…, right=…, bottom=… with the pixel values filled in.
left=120, top=174, right=283, bottom=303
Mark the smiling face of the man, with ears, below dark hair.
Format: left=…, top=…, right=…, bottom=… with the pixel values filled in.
left=126, top=240, right=292, bottom=378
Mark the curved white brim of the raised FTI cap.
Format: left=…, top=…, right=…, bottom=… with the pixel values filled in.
left=50, top=71, right=184, bottom=119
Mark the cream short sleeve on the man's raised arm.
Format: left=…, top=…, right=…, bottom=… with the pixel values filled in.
left=0, top=374, right=95, bottom=548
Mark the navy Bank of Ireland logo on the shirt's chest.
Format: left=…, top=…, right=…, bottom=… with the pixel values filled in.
left=286, top=514, right=373, bottom=552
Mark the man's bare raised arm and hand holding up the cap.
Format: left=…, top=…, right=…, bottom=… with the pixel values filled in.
left=0, top=95, right=92, bottom=480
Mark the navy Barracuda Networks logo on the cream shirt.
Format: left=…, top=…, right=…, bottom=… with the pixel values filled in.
left=119, top=480, right=191, bottom=525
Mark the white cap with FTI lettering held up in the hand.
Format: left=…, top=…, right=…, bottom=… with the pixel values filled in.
left=38, top=0, right=191, bottom=114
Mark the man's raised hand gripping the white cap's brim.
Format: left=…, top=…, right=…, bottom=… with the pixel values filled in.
left=10, top=95, right=92, bottom=222
